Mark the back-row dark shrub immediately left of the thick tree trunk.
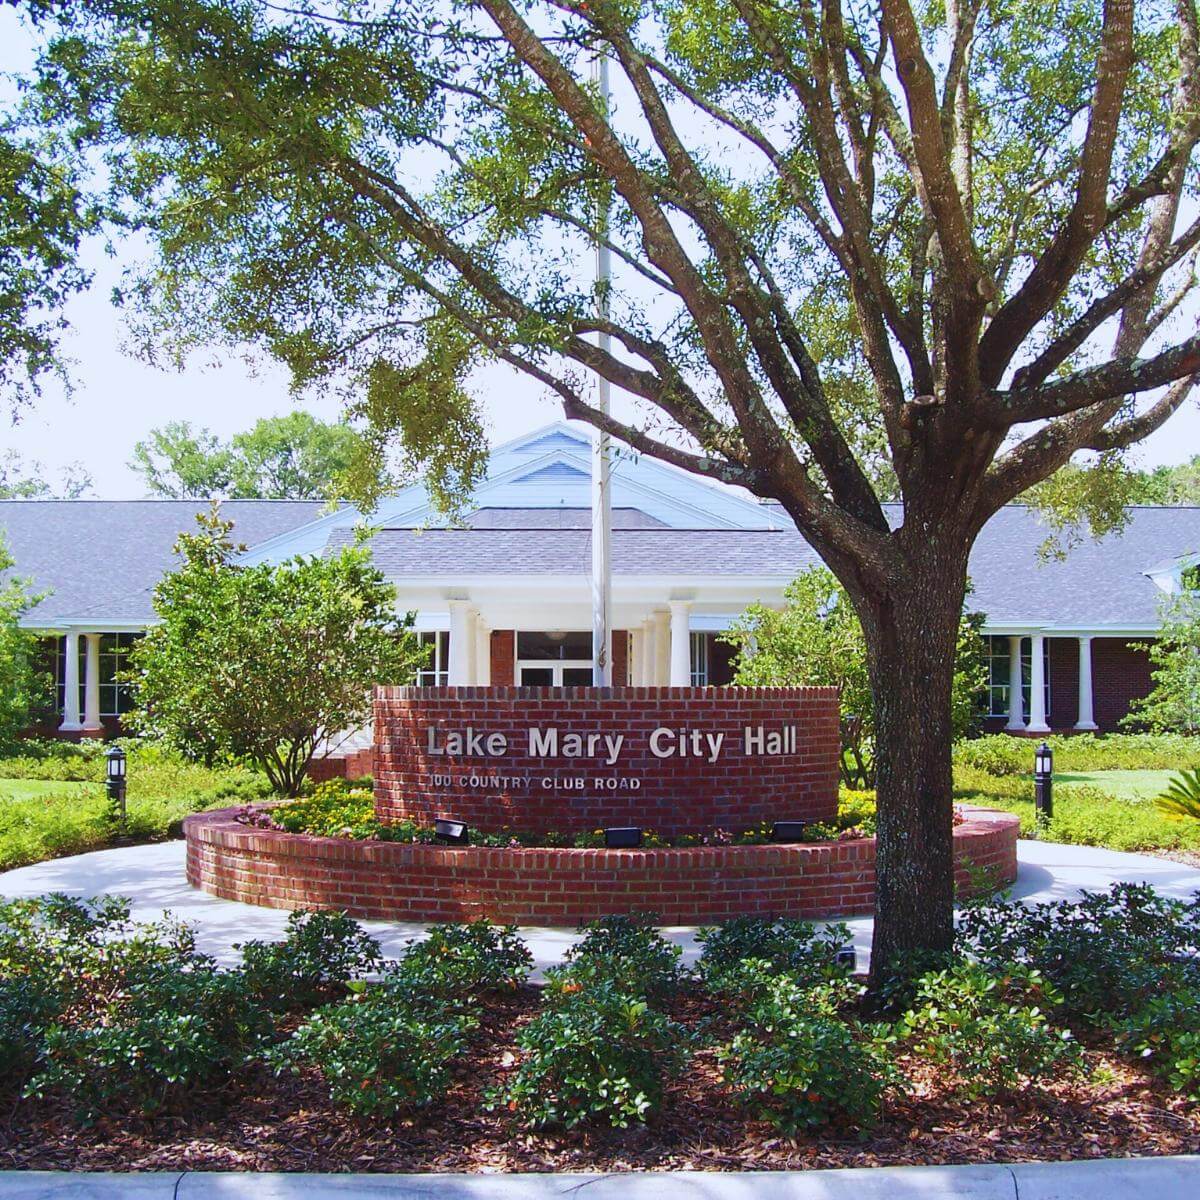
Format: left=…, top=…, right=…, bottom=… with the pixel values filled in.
left=696, top=917, right=851, bottom=992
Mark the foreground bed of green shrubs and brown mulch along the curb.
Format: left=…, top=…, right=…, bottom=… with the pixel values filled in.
left=7, top=884, right=1200, bottom=1171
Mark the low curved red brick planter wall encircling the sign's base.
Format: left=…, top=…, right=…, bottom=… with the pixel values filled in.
left=184, top=809, right=1018, bottom=925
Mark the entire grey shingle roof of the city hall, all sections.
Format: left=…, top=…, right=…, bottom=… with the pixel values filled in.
left=0, top=500, right=1200, bottom=630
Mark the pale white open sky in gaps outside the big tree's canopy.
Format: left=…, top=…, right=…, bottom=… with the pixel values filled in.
left=0, top=7, right=1200, bottom=498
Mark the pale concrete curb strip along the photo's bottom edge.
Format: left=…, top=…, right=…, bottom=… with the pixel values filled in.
left=7, top=1157, right=1200, bottom=1200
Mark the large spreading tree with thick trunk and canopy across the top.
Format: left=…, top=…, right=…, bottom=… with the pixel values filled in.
left=26, top=0, right=1200, bottom=980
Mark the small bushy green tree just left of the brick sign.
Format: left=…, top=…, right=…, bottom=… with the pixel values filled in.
left=130, top=506, right=421, bottom=796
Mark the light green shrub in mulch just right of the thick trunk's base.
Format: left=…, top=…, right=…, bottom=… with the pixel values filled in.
left=896, top=962, right=1080, bottom=1098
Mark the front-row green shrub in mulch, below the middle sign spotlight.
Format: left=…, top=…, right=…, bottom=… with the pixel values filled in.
left=487, top=979, right=689, bottom=1129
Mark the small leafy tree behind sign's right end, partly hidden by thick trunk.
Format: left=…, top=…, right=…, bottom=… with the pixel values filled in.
left=725, top=566, right=985, bottom=787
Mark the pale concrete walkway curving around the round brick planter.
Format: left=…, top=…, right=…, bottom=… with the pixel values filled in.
left=0, top=841, right=1200, bottom=969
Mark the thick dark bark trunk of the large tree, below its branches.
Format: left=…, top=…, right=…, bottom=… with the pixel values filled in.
left=862, top=547, right=966, bottom=992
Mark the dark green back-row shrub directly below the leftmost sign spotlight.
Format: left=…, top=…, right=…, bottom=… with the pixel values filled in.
left=384, top=920, right=533, bottom=1002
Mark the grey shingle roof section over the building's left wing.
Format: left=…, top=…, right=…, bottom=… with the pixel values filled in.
left=0, top=500, right=323, bottom=625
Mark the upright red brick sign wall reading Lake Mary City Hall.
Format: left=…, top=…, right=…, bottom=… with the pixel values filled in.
left=374, top=688, right=839, bottom=836
